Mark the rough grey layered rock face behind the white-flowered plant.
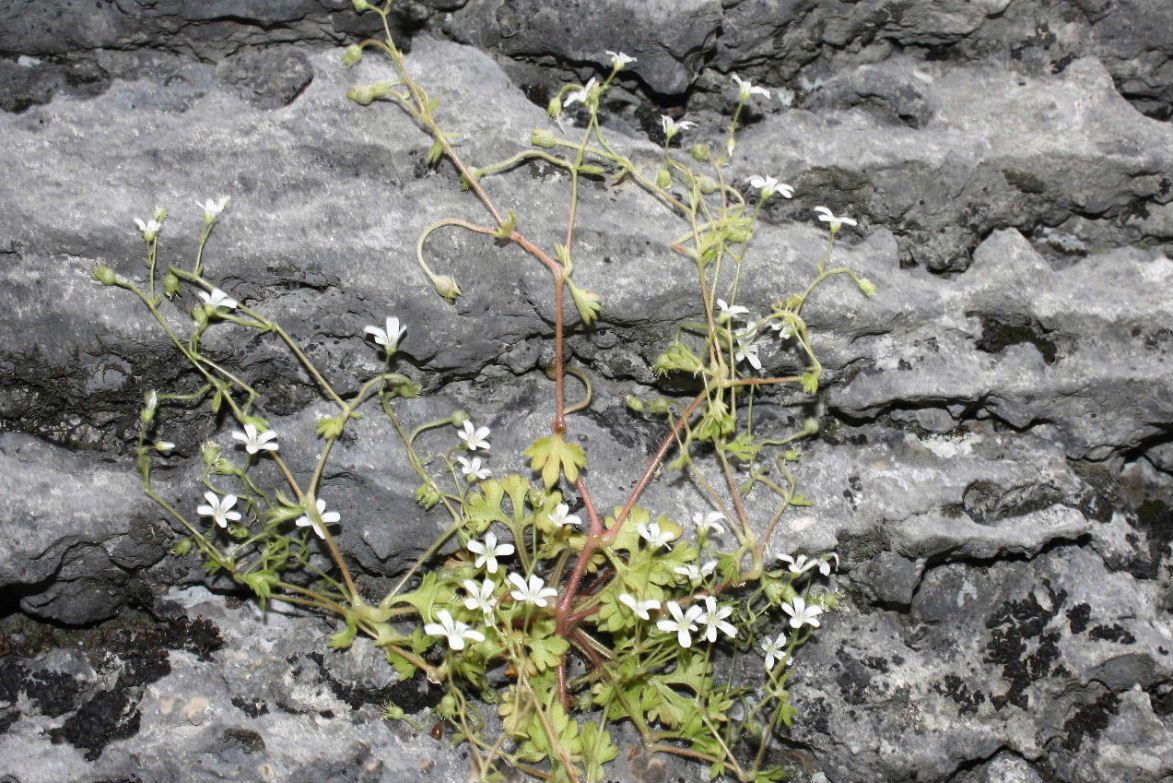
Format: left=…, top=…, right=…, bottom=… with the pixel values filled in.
left=0, top=0, right=1173, bottom=783
